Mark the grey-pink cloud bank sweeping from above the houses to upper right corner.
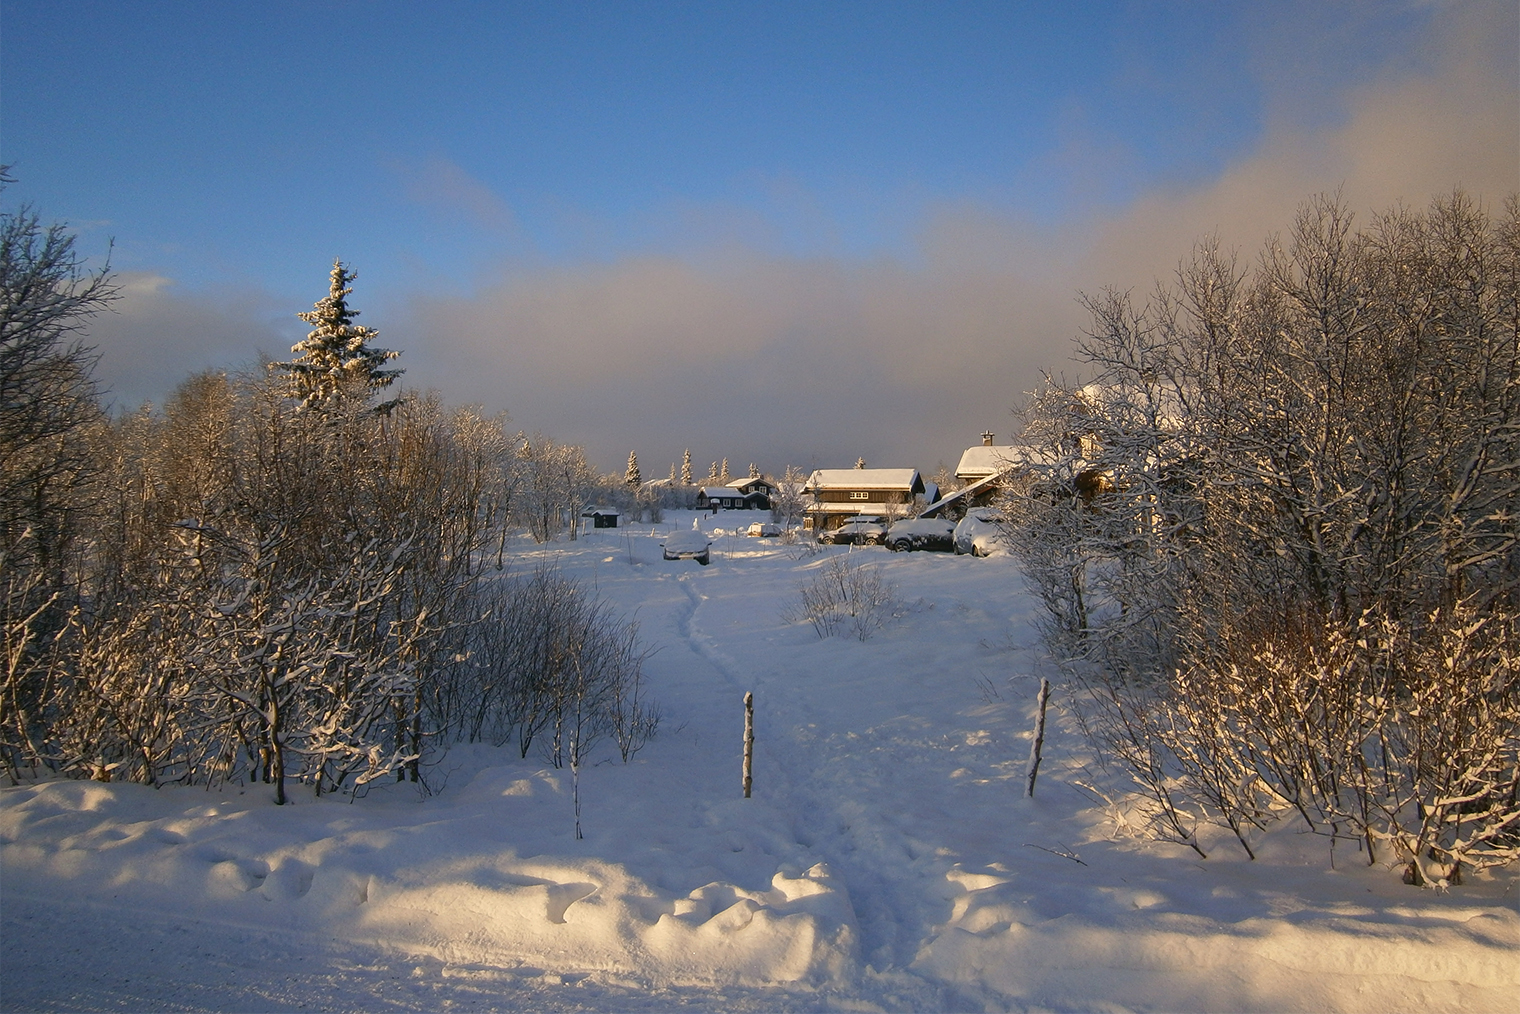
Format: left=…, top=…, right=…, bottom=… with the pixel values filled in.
left=88, top=5, right=1520, bottom=474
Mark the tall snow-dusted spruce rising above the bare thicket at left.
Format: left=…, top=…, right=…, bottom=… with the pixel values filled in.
left=271, top=260, right=403, bottom=412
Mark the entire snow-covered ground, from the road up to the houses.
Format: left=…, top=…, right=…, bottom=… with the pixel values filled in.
left=0, top=514, right=1520, bottom=1011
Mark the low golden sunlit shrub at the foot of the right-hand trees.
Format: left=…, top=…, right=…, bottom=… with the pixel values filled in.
left=1082, top=607, right=1520, bottom=883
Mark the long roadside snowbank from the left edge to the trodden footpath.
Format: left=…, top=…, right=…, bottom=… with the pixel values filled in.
left=0, top=769, right=857, bottom=987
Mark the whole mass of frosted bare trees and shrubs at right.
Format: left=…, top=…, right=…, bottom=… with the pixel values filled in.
left=1008, top=193, right=1520, bottom=885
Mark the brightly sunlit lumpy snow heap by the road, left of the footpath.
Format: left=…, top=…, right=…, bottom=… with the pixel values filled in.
left=354, top=857, right=856, bottom=985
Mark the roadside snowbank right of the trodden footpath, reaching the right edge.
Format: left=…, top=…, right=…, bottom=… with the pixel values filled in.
left=914, top=870, right=1520, bottom=1011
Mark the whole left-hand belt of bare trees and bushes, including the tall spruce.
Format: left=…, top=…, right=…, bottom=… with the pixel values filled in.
left=0, top=208, right=658, bottom=801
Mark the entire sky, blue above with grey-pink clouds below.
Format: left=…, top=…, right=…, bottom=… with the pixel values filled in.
left=0, top=0, right=1520, bottom=471
